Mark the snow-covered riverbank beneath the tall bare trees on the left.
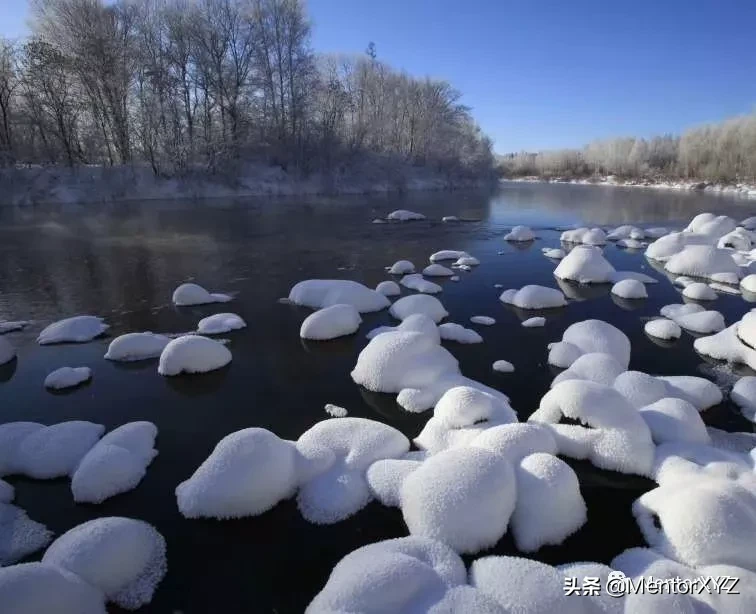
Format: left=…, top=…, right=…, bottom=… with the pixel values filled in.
left=0, top=159, right=496, bottom=205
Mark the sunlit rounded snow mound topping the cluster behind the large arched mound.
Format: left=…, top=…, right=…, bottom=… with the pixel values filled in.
left=549, top=320, right=630, bottom=369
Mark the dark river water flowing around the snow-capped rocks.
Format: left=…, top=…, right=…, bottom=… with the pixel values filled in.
left=0, top=184, right=756, bottom=613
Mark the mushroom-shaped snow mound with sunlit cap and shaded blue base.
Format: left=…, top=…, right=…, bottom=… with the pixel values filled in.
left=296, top=417, right=409, bottom=524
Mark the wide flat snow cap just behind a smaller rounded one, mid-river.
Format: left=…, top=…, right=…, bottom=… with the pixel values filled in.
left=289, top=279, right=391, bottom=313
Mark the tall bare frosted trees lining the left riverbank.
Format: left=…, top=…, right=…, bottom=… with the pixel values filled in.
left=0, top=0, right=494, bottom=176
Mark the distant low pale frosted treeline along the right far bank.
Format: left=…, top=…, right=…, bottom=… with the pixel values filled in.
left=500, top=112, right=756, bottom=183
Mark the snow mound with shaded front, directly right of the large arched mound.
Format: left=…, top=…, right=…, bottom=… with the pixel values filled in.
left=639, top=398, right=710, bottom=444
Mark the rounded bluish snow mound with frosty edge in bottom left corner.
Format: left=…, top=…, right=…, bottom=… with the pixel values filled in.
left=42, top=516, right=167, bottom=610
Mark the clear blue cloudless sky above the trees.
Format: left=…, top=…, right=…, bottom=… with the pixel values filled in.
left=0, top=0, right=756, bottom=152
